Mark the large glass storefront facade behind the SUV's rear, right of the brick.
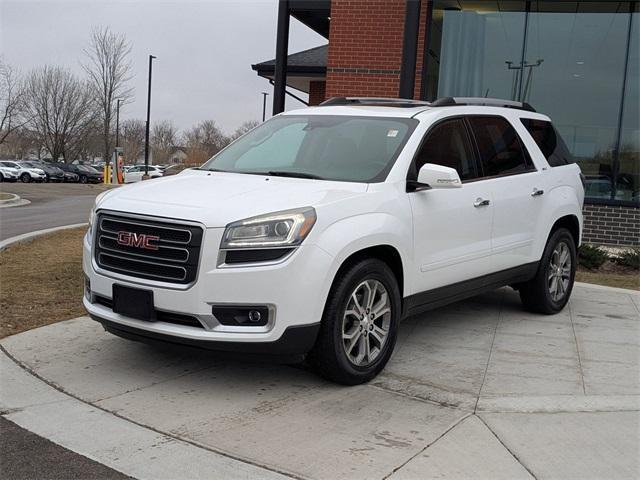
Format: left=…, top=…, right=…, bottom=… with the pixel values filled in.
left=427, top=0, right=640, bottom=202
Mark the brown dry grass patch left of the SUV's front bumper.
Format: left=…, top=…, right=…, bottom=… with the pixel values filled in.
left=0, top=228, right=86, bottom=338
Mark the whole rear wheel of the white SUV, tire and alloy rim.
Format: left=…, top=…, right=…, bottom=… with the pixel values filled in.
left=520, top=228, right=577, bottom=315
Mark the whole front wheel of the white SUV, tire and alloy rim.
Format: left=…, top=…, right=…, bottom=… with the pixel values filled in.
left=309, top=259, right=401, bottom=385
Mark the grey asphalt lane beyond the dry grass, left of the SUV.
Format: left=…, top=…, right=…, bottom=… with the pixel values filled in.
left=0, top=183, right=109, bottom=240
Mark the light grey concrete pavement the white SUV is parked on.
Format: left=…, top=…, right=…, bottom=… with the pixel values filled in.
left=0, top=284, right=640, bottom=479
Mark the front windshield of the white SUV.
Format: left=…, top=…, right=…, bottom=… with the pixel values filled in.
left=202, top=115, right=418, bottom=183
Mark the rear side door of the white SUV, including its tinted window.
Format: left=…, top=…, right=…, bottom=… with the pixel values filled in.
left=467, top=115, right=545, bottom=272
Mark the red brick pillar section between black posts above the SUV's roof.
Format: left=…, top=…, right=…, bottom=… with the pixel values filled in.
left=326, top=0, right=404, bottom=98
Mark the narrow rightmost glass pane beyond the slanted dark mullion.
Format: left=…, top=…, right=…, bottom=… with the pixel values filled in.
left=616, top=4, right=640, bottom=203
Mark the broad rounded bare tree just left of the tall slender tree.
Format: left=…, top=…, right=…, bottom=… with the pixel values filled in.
left=25, top=66, right=96, bottom=161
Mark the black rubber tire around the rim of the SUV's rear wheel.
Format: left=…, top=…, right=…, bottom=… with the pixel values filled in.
left=519, top=228, right=577, bottom=315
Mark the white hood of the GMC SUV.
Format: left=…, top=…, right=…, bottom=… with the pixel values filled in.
left=97, top=170, right=367, bottom=228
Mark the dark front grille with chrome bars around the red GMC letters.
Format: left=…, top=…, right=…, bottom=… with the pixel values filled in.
left=94, top=213, right=202, bottom=284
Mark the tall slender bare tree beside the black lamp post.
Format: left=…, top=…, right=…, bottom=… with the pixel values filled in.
left=83, top=27, right=133, bottom=162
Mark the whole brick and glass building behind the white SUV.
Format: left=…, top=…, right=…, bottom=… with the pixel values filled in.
left=252, top=0, right=640, bottom=246
